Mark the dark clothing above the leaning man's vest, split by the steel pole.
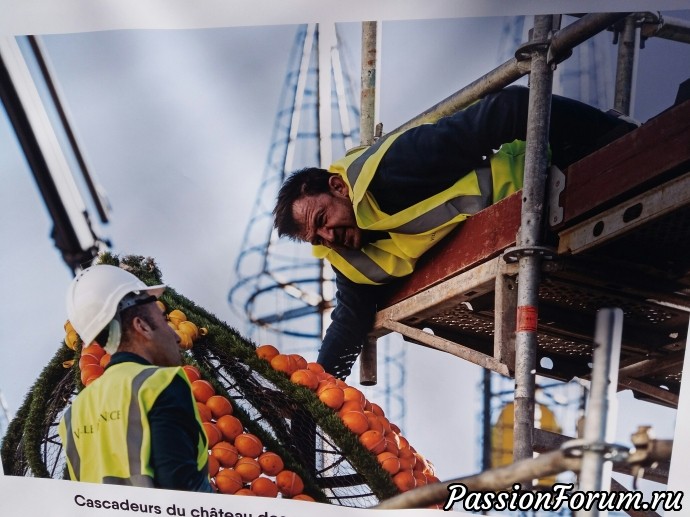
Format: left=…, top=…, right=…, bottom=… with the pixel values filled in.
left=369, top=86, right=635, bottom=213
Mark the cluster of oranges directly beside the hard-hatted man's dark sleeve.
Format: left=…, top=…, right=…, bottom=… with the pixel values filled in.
left=182, top=365, right=314, bottom=501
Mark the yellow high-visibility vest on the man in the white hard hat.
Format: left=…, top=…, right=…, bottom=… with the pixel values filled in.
left=58, top=362, right=208, bottom=487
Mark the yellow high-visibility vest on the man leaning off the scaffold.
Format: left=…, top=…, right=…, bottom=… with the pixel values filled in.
left=312, top=133, right=525, bottom=285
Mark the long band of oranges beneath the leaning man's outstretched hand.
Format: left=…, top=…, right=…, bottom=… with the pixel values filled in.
left=256, top=345, right=439, bottom=492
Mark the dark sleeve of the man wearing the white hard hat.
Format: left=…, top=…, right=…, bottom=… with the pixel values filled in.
left=148, top=376, right=212, bottom=492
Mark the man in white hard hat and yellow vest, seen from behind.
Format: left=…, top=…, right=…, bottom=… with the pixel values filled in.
left=58, top=265, right=211, bottom=492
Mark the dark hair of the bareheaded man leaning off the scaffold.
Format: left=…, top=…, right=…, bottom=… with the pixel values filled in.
left=273, top=167, right=332, bottom=239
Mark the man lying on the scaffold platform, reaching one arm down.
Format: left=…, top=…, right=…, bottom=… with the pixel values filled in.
left=273, top=86, right=636, bottom=378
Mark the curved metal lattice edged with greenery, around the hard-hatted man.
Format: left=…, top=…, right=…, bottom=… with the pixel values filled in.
left=2, top=258, right=397, bottom=507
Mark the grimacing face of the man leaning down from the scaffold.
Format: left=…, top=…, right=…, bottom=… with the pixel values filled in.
left=292, top=175, right=362, bottom=250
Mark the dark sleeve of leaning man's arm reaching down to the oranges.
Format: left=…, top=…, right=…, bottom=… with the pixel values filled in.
left=317, top=268, right=382, bottom=379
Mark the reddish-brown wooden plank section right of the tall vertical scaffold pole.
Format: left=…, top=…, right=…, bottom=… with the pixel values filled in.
left=556, top=101, right=690, bottom=228
